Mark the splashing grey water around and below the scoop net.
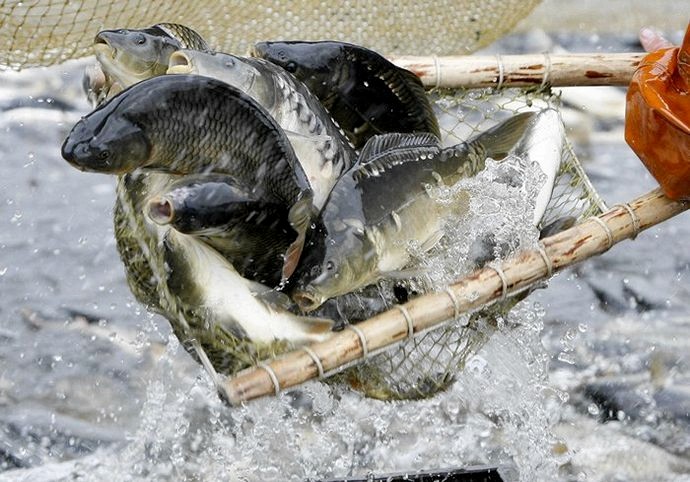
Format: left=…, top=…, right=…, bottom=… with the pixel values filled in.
left=0, top=40, right=690, bottom=480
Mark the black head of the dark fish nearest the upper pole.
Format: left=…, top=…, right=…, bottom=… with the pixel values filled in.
left=251, top=41, right=341, bottom=96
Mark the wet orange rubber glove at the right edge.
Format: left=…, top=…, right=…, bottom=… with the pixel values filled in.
left=625, top=24, right=690, bottom=200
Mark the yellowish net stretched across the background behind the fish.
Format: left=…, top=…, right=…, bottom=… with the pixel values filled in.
left=0, top=0, right=539, bottom=69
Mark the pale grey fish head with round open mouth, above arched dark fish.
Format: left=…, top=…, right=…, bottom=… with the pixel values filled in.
left=167, top=49, right=259, bottom=93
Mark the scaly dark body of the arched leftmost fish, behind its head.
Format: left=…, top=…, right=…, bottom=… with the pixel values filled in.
left=119, top=75, right=310, bottom=205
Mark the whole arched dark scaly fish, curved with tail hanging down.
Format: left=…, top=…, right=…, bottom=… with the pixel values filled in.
left=62, top=75, right=318, bottom=279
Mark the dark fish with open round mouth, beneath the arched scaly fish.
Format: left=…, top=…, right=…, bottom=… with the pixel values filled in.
left=145, top=174, right=293, bottom=286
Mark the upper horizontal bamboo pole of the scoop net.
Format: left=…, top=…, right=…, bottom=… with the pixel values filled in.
left=390, top=53, right=646, bottom=88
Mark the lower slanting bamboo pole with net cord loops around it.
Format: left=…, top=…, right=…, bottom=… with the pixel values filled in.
left=219, top=189, right=690, bottom=403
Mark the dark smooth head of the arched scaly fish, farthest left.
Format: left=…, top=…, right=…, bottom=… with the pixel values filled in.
left=62, top=99, right=151, bottom=174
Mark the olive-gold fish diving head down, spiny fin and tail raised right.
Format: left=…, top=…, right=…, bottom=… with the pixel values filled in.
left=291, top=112, right=535, bottom=312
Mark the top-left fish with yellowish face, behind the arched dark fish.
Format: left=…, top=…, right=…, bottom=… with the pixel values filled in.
left=91, top=23, right=210, bottom=101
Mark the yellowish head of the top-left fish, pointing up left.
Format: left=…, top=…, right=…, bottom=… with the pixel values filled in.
left=94, top=27, right=181, bottom=88
